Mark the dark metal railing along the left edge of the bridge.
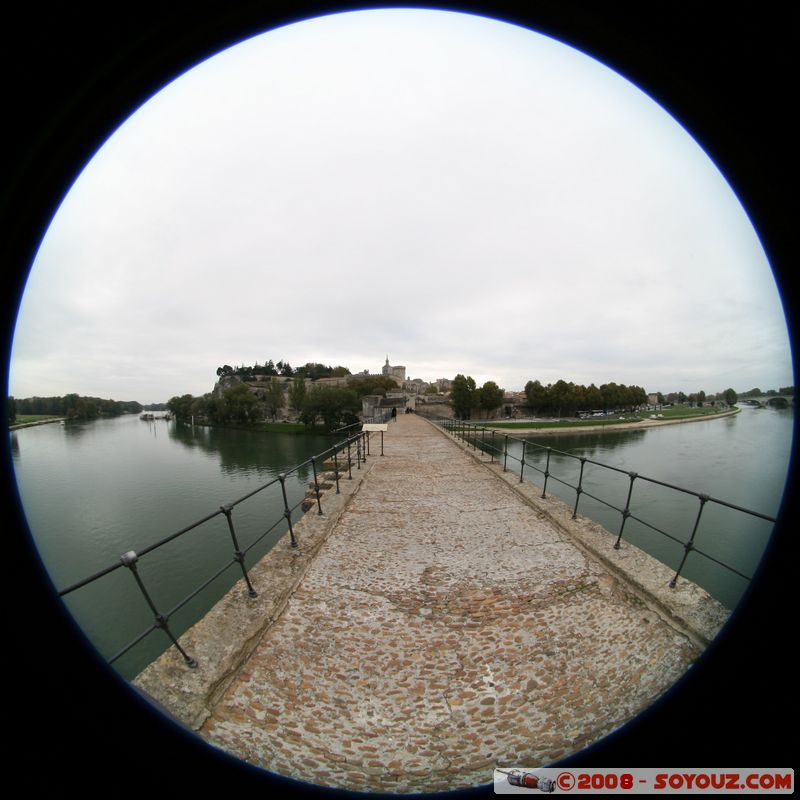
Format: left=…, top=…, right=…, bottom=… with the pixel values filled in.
left=58, top=432, right=369, bottom=667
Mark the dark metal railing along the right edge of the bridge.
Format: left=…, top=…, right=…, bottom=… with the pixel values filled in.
left=434, top=419, right=776, bottom=589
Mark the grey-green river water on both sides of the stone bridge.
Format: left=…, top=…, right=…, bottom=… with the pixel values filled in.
left=10, top=407, right=793, bottom=678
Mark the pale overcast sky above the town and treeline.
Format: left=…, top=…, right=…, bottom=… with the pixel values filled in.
left=10, top=10, right=794, bottom=403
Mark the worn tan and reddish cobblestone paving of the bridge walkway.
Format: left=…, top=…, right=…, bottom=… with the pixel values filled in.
left=201, top=415, right=698, bottom=793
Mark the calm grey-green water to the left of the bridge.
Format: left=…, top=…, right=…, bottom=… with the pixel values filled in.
left=11, top=415, right=332, bottom=678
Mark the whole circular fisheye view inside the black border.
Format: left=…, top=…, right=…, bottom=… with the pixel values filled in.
left=8, top=3, right=794, bottom=794
